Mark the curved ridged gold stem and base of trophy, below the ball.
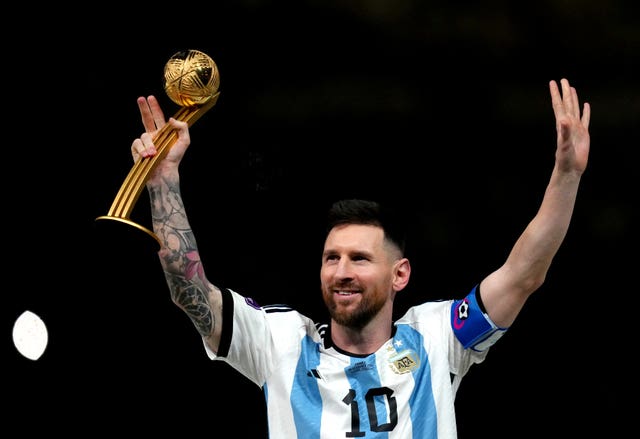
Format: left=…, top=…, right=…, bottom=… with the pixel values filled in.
left=96, top=92, right=220, bottom=245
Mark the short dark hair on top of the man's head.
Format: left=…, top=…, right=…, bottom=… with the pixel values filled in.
left=326, top=198, right=406, bottom=254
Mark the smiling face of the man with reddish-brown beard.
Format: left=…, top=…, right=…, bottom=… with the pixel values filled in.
left=320, top=224, right=397, bottom=328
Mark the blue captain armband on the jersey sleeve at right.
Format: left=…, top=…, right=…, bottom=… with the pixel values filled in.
left=451, top=285, right=509, bottom=352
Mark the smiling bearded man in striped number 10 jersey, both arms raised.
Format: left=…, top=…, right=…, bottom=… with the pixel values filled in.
left=131, top=79, right=591, bottom=439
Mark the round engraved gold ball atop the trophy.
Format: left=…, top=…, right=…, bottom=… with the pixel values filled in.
left=164, top=49, right=220, bottom=107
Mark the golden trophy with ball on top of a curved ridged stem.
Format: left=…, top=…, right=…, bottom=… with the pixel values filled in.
left=96, top=49, right=220, bottom=245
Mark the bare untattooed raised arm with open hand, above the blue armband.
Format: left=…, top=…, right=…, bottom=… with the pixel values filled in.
left=480, top=79, right=591, bottom=327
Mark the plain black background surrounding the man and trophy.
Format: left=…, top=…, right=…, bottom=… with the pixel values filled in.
left=1, top=0, right=640, bottom=438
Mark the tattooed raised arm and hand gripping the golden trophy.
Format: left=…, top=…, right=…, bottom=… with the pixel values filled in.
left=131, top=96, right=222, bottom=352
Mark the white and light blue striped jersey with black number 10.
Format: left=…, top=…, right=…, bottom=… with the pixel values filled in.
left=205, top=288, right=505, bottom=439
